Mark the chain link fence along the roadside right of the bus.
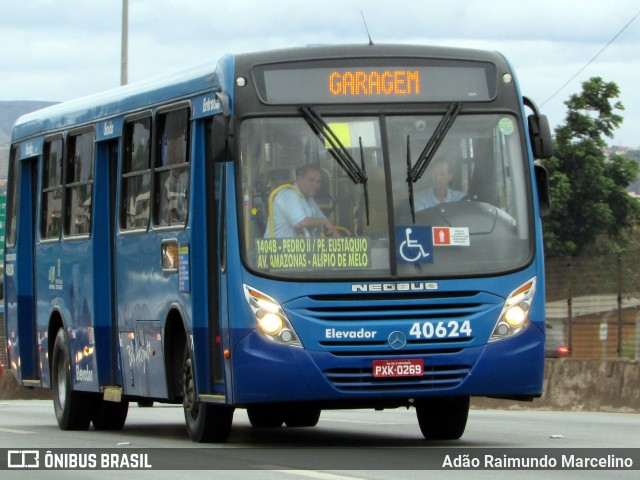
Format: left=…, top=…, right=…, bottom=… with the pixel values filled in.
left=546, top=251, right=640, bottom=359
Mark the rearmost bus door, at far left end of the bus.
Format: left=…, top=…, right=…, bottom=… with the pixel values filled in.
left=5, top=149, right=40, bottom=385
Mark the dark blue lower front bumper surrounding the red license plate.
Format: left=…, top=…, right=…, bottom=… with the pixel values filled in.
left=234, top=327, right=544, bottom=404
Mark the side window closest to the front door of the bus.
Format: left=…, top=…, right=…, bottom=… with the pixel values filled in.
left=154, top=108, right=190, bottom=226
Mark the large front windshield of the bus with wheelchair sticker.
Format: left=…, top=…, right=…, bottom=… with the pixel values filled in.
left=240, top=112, right=533, bottom=279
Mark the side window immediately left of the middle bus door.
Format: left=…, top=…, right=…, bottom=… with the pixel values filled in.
left=65, top=132, right=94, bottom=236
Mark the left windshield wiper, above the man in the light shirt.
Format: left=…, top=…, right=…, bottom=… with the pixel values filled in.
left=300, top=105, right=369, bottom=225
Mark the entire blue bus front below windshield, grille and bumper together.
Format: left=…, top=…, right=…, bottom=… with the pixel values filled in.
left=231, top=268, right=544, bottom=404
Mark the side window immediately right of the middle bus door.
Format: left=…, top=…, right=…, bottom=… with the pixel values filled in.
left=120, top=118, right=151, bottom=230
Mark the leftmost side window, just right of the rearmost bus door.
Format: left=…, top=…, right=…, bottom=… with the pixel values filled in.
left=40, top=138, right=64, bottom=240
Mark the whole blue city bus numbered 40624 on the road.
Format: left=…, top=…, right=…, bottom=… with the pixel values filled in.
left=4, top=45, right=551, bottom=442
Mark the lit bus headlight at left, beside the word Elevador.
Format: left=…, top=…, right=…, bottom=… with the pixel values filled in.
left=244, top=285, right=302, bottom=347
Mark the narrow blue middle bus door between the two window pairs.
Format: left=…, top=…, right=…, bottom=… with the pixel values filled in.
left=93, top=134, right=121, bottom=386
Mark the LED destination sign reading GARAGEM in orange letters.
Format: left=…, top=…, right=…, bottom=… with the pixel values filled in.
left=254, top=61, right=495, bottom=105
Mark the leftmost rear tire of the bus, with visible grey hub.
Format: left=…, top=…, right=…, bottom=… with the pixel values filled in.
left=51, top=328, right=99, bottom=430
